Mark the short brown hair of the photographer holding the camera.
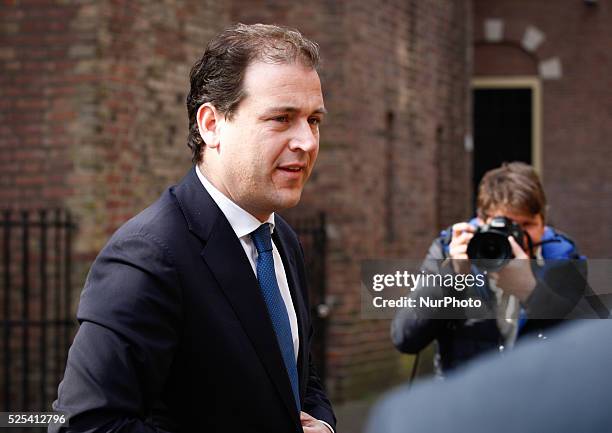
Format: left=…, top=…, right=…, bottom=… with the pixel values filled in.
left=477, top=162, right=546, bottom=220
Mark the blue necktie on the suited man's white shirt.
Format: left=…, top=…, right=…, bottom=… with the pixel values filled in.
left=251, top=223, right=301, bottom=410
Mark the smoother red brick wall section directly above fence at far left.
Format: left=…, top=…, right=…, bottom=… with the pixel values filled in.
left=0, top=1, right=82, bottom=207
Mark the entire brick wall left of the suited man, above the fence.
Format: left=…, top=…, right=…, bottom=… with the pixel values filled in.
left=0, top=1, right=226, bottom=268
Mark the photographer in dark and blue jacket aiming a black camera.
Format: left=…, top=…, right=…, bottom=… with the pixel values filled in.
left=391, top=162, right=586, bottom=374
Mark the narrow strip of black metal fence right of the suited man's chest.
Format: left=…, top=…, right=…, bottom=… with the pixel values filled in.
left=289, top=213, right=330, bottom=381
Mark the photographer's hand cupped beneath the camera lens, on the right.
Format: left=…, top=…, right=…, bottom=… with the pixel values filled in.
left=489, top=236, right=536, bottom=302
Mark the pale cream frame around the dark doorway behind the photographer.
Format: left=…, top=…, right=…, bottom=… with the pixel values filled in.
left=472, top=75, right=542, bottom=179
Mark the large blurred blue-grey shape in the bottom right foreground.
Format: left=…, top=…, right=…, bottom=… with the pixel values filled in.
left=366, top=319, right=612, bottom=433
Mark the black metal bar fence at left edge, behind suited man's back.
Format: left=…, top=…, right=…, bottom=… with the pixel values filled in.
left=0, top=209, right=76, bottom=412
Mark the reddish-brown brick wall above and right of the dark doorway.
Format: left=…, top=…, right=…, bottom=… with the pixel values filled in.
left=474, top=0, right=612, bottom=258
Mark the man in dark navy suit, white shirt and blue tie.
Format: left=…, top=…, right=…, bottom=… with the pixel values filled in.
left=50, top=25, right=335, bottom=433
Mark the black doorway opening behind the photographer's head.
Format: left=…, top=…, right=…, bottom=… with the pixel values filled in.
left=472, top=88, right=533, bottom=210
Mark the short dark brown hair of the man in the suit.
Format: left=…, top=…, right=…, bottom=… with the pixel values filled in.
left=187, top=24, right=319, bottom=164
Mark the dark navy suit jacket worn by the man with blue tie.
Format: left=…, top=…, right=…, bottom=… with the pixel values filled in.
left=50, top=169, right=335, bottom=433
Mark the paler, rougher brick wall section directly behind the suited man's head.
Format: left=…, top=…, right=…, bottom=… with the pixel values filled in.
left=68, top=1, right=228, bottom=252
